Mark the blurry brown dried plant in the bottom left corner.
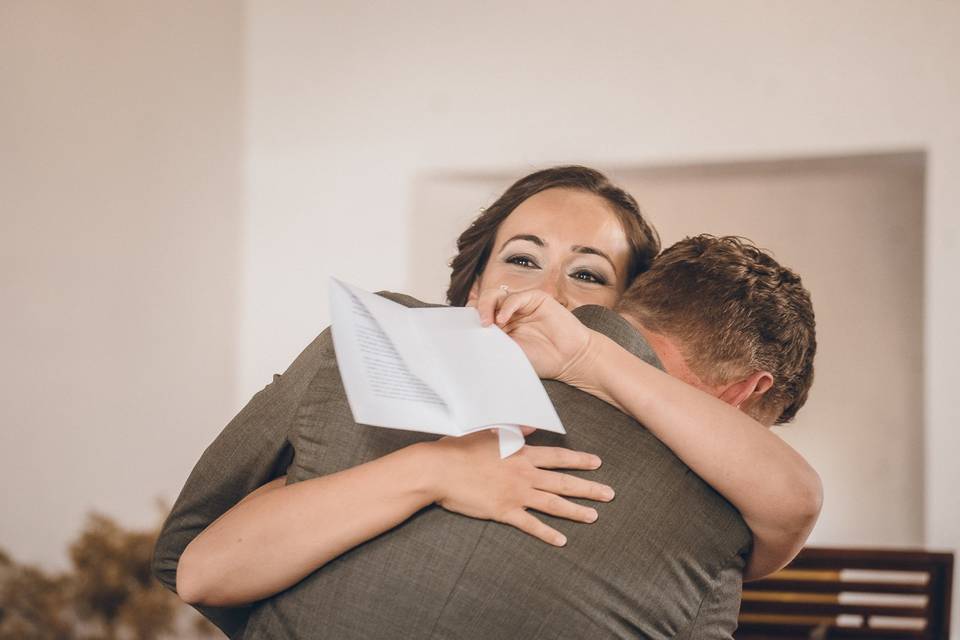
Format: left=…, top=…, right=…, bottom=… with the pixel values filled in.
left=0, top=505, right=219, bottom=640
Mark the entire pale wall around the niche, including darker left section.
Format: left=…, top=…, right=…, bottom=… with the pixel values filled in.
left=0, top=0, right=960, bottom=632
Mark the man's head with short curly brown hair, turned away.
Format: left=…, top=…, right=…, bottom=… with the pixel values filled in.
left=617, top=235, right=817, bottom=425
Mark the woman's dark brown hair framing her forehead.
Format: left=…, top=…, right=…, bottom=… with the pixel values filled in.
left=447, top=165, right=660, bottom=307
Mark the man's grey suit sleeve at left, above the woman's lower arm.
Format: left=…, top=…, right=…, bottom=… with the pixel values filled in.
left=153, top=329, right=329, bottom=637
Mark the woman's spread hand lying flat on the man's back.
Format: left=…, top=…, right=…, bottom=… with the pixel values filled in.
left=430, top=430, right=614, bottom=546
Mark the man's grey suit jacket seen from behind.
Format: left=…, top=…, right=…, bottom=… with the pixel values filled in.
left=154, top=294, right=750, bottom=639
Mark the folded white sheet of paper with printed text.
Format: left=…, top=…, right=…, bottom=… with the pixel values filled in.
left=330, top=278, right=566, bottom=458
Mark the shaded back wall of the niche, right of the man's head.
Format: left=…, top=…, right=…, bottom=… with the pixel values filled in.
left=622, top=155, right=925, bottom=546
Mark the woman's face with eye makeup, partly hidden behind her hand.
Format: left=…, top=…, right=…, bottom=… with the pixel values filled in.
left=470, top=188, right=630, bottom=309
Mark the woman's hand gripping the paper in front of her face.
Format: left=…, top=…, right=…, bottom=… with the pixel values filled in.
left=477, top=288, right=595, bottom=386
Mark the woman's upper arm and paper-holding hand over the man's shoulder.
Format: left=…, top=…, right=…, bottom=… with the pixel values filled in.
left=478, top=291, right=823, bottom=580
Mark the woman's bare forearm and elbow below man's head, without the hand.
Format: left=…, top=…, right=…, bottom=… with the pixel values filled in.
left=574, top=333, right=823, bottom=580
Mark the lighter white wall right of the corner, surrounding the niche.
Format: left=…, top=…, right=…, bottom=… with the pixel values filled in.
left=248, top=0, right=960, bottom=628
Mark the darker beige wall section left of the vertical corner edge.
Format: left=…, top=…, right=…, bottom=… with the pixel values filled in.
left=0, top=1, right=243, bottom=567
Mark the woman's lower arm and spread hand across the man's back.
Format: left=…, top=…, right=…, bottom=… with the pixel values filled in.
left=177, top=431, right=613, bottom=606
